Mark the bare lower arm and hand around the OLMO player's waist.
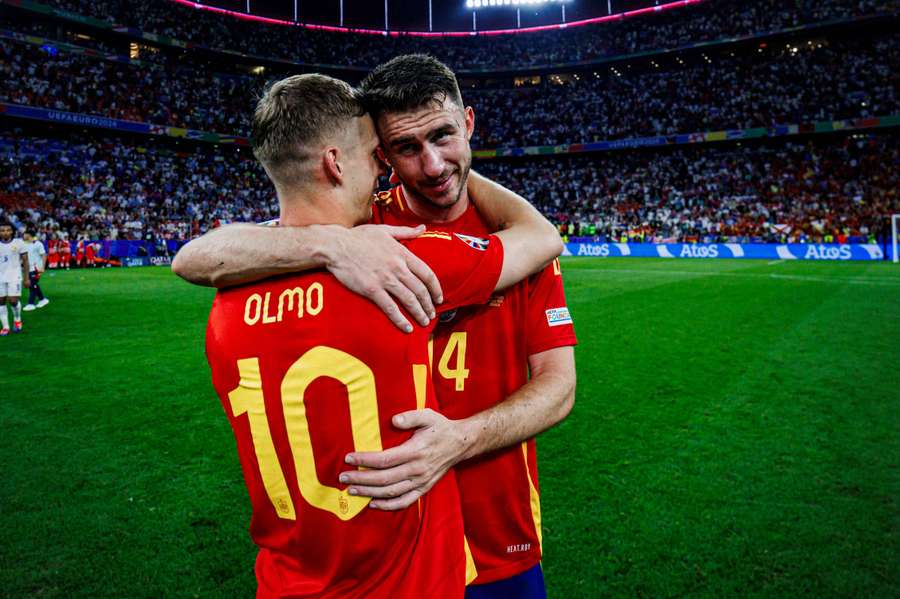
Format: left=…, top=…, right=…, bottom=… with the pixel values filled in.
left=341, top=346, right=575, bottom=510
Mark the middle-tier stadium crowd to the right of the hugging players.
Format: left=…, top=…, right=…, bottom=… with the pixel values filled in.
left=464, top=35, right=900, bottom=147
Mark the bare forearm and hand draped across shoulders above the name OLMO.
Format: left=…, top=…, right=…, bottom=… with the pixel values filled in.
left=172, top=223, right=443, bottom=332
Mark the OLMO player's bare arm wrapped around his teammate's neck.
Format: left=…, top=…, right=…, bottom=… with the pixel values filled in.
left=468, top=171, right=563, bottom=289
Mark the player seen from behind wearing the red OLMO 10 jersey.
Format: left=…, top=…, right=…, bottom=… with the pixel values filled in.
left=200, top=75, right=560, bottom=598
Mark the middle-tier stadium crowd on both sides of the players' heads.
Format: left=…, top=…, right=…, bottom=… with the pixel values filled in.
left=0, top=34, right=900, bottom=147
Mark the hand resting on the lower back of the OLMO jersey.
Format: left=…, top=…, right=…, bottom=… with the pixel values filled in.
left=339, top=409, right=465, bottom=511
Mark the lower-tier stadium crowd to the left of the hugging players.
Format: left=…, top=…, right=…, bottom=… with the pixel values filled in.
left=0, top=136, right=278, bottom=246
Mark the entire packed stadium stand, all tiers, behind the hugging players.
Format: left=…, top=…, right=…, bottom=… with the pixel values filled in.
left=0, top=0, right=900, bottom=250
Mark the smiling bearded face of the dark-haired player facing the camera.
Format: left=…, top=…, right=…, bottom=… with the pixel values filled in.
left=378, top=99, right=475, bottom=209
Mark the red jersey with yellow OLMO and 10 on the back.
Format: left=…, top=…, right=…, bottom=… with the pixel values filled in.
left=206, top=232, right=503, bottom=598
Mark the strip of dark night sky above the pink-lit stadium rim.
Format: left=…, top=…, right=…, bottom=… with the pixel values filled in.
left=197, top=0, right=664, bottom=31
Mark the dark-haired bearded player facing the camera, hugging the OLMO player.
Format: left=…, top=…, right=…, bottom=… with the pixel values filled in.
left=174, top=55, right=576, bottom=597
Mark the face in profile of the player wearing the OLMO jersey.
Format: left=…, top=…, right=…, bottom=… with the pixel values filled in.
left=346, top=115, right=385, bottom=224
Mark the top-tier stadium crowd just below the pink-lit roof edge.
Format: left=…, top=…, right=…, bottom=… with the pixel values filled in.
left=29, top=0, right=896, bottom=70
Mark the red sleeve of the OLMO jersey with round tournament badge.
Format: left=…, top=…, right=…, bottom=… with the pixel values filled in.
left=406, top=231, right=503, bottom=312
